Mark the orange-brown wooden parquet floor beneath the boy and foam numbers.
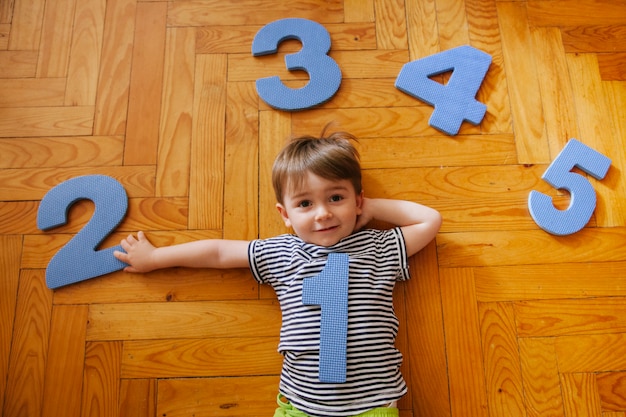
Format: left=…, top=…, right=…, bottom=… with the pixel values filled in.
left=0, top=0, right=626, bottom=417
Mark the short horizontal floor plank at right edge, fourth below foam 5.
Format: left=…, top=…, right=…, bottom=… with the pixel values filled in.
left=554, top=333, right=626, bottom=373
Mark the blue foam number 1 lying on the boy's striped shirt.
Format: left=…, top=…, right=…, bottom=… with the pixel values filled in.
left=302, top=253, right=349, bottom=383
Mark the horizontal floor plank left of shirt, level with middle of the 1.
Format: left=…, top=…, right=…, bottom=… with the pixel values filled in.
left=87, top=301, right=280, bottom=340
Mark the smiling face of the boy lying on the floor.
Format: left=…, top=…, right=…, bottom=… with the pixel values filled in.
left=276, top=172, right=363, bottom=246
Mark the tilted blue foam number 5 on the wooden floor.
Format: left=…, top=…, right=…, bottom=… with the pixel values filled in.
left=528, top=139, right=611, bottom=236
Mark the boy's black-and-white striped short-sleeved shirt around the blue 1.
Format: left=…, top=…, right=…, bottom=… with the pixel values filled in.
left=248, top=228, right=409, bottom=416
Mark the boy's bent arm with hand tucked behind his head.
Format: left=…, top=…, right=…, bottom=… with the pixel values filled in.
left=357, top=198, right=441, bottom=256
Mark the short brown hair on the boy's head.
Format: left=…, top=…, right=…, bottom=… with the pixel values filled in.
left=272, top=128, right=362, bottom=204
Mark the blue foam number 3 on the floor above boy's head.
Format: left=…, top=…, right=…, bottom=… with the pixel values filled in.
left=252, top=18, right=341, bottom=110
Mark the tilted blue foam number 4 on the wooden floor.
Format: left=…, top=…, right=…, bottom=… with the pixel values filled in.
left=395, top=45, right=491, bottom=135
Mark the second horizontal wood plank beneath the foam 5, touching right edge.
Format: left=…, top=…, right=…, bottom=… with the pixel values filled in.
left=474, top=262, right=626, bottom=302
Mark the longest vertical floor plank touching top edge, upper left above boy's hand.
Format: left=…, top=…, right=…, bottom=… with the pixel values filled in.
left=124, top=2, right=167, bottom=165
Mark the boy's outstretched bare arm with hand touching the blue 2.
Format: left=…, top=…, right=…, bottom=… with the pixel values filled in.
left=114, top=232, right=250, bottom=272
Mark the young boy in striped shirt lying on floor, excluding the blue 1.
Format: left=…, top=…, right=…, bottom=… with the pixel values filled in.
left=115, top=132, right=441, bottom=417
